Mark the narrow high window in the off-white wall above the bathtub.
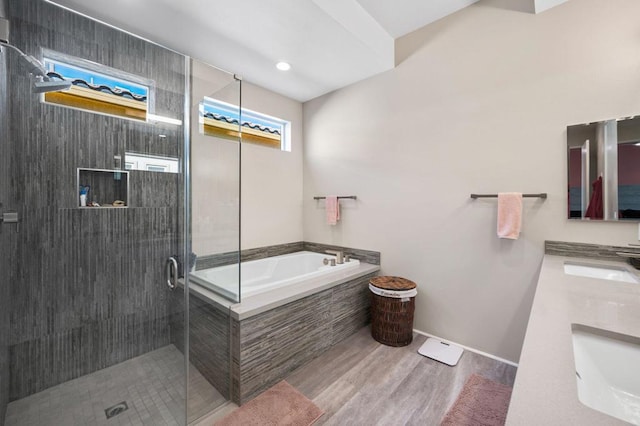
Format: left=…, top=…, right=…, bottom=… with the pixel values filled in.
left=200, top=98, right=291, bottom=151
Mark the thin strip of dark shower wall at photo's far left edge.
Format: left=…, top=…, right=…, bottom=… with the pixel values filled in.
left=0, top=49, right=16, bottom=425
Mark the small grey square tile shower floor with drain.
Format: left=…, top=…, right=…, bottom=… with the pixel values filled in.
left=5, top=345, right=225, bottom=426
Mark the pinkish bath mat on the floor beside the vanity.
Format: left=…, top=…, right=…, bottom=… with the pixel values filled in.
left=440, top=374, right=511, bottom=426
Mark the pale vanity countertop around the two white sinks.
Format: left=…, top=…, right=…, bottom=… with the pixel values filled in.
left=506, top=255, right=640, bottom=426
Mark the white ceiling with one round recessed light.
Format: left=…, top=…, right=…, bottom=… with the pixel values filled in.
left=46, top=0, right=478, bottom=102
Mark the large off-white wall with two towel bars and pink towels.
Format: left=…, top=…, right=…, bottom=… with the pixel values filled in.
left=304, top=0, right=640, bottom=362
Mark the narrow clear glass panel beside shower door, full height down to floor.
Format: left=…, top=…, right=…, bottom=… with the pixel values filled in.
left=188, top=60, right=241, bottom=420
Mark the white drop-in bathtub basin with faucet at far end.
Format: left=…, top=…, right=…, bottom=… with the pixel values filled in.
left=189, top=251, right=360, bottom=300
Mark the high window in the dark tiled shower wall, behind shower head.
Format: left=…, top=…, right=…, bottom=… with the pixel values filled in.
left=44, top=50, right=153, bottom=121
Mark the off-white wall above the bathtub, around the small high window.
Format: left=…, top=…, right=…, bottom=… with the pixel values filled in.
left=191, top=61, right=302, bottom=256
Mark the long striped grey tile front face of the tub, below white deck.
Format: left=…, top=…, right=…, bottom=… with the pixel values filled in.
left=231, top=272, right=376, bottom=404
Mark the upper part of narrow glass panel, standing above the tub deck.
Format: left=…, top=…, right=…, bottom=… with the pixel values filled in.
left=191, top=61, right=241, bottom=302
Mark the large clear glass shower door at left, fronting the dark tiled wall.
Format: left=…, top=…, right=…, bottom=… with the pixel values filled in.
left=0, top=0, right=188, bottom=425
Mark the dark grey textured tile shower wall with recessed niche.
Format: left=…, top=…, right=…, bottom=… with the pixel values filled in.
left=7, top=0, right=185, bottom=400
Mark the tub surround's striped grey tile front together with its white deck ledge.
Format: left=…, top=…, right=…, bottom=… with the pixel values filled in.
left=184, top=250, right=380, bottom=404
